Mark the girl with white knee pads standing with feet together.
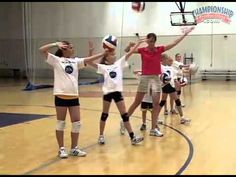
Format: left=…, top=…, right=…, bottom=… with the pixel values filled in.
left=39, top=41, right=106, bottom=158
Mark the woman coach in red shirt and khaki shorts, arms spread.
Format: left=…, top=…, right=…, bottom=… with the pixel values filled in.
left=125, top=27, right=194, bottom=137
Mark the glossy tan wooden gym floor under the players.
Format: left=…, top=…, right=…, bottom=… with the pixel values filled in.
left=0, top=79, right=236, bottom=175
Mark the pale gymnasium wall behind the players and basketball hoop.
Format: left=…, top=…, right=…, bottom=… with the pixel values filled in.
left=0, top=2, right=236, bottom=78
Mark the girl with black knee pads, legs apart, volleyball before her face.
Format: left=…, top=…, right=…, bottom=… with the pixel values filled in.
left=86, top=39, right=145, bottom=145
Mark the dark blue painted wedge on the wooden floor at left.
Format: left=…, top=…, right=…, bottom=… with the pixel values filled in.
left=0, top=112, right=52, bottom=127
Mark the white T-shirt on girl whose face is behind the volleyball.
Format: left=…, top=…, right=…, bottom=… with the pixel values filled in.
left=97, top=55, right=128, bottom=95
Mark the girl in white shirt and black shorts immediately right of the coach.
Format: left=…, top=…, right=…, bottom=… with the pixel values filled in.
left=159, top=54, right=190, bottom=124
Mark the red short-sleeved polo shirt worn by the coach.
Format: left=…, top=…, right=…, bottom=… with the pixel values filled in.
left=138, top=46, right=165, bottom=75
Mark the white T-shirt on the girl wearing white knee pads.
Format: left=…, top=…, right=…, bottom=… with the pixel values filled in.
left=46, top=53, right=85, bottom=96
